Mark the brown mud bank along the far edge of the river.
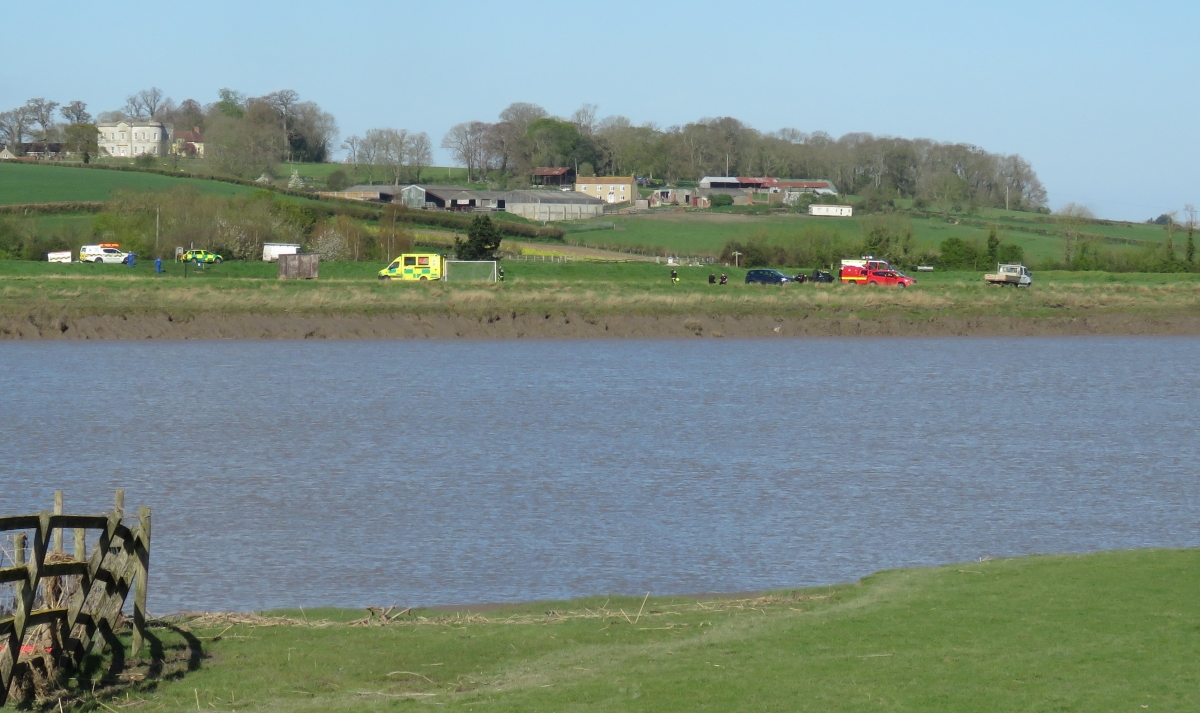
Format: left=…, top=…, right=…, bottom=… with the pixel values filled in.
left=7, top=312, right=1200, bottom=340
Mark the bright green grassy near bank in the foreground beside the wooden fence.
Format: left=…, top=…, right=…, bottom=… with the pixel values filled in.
left=30, top=550, right=1200, bottom=713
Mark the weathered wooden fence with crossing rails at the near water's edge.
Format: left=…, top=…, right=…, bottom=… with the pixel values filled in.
left=0, top=490, right=150, bottom=707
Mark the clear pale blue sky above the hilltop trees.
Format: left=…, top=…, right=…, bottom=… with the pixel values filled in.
left=0, top=0, right=1200, bottom=220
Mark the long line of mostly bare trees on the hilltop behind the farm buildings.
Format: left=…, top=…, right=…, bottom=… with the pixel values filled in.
left=442, top=102, right=1046, bottom=210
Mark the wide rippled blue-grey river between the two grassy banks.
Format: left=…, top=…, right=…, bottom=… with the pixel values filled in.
left=0, top=337, right=1200, bottom=613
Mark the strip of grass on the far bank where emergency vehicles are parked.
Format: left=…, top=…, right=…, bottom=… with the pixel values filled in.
left=0, top=260, right=1200, bottom=322
